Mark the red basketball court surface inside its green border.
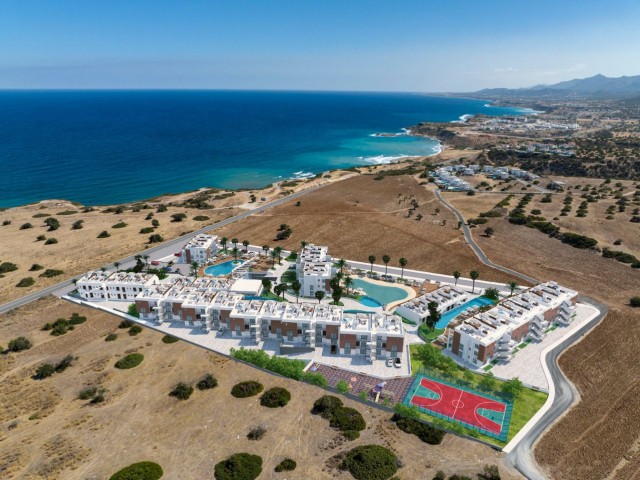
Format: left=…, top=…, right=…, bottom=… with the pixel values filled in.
left=411, top=378, right=506, bottom=435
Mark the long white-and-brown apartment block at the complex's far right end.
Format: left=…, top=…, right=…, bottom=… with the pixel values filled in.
left=447, top=282, right=578, bottom=366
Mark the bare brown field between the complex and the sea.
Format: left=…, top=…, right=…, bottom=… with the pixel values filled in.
left=216, top=175, right=509, bottom=282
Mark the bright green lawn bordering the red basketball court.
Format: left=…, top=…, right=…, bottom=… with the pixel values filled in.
left=409, top=345, right=548, bottom=447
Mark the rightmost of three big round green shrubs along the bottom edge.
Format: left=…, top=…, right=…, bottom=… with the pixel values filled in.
left=340, top=445, right=398, bottom=480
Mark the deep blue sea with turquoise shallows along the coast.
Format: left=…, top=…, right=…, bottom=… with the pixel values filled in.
left=0, top=91, right=526, bottom=207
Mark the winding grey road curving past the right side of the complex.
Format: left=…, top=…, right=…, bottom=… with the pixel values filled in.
left=434, top=190, right=609, bottom=480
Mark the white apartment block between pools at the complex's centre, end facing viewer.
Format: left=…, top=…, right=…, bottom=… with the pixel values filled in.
left=296, top=244, right=334, bottom=297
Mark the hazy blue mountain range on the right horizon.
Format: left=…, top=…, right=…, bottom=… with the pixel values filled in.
left=472, top=75, right=640, bottom=100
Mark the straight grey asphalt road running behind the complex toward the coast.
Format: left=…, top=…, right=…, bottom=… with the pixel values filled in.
left=0, top=185, right=324, bottom=314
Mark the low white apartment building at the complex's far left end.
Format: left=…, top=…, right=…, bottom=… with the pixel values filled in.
left=76, top=271, right=160, bottom=301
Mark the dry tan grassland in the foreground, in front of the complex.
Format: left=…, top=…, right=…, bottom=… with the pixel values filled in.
left=0, top=298, right=519, bottom=480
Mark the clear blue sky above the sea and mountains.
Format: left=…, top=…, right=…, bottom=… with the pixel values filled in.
left=0, top=0, right=640, bottom=92
